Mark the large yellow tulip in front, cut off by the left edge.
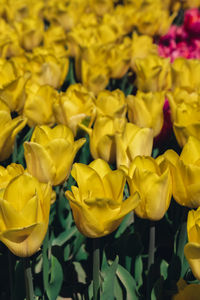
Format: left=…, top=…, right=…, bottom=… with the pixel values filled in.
left=0, top=174, right=51, bottom=257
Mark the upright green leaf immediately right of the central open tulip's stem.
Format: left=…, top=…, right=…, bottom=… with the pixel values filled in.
left=101, top=256, right=119, bottom=300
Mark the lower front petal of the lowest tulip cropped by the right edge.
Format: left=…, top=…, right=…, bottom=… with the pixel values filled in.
left=184, top=243, right=200, bottom=280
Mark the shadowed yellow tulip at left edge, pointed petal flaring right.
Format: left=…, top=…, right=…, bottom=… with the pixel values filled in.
left=0, top=110, right=27, bottom=161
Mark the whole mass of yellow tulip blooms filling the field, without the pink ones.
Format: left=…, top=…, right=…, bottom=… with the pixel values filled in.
left=0, top=0, right=200, bottom=299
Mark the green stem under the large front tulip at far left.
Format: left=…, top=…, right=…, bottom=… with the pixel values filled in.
left=23, top=257, right=35, bottom=300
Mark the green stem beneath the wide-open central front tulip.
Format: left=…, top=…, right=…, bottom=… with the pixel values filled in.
left=93, top=239, right=100, bottom=300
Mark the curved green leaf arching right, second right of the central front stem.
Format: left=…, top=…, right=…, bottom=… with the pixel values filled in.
left=117, top=265, right=139, bottom=300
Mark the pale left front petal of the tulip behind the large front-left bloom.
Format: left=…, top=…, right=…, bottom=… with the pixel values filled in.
left=24, top=142, right=56, bottom=183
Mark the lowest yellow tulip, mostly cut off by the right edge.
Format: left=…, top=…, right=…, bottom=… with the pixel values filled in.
left=184, top=208, right=200, bottom=280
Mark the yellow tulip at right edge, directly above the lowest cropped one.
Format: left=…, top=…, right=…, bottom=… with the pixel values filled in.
left=164, top=137, right=200, bottom=208
